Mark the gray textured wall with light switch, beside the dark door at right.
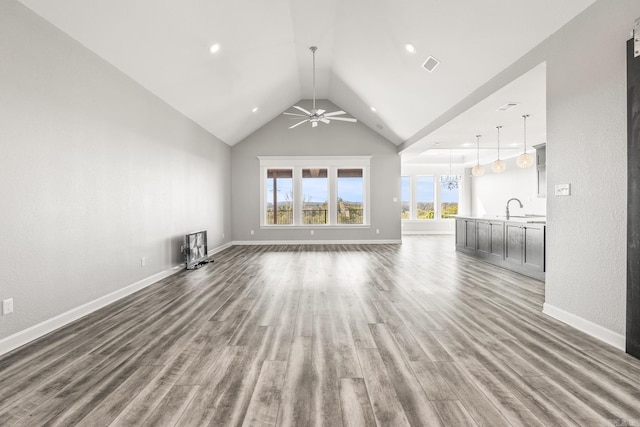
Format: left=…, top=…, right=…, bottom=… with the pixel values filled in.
left=546, top=0, right=640, bottom=342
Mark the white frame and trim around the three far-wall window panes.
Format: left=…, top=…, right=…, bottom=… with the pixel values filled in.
left=257, top=156, right=371, bottom=229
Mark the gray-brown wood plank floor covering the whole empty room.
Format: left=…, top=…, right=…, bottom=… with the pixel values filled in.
left=0, top=236, right=640, bottom=427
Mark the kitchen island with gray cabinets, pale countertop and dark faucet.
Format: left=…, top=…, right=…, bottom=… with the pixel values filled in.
left=456, top=215, right=546, bottom=280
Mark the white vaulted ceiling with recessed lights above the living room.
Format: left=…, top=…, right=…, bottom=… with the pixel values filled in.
left=20, top=0, right=595, bottom=157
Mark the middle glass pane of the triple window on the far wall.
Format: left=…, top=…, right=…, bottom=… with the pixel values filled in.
left=302, top=168, right=329, bottom=224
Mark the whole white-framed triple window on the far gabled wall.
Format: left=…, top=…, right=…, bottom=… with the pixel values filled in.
left=258, top=156, right=370, bottom=227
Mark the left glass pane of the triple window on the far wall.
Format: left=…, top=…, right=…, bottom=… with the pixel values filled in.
left=266, top=169, right=293, bottom=224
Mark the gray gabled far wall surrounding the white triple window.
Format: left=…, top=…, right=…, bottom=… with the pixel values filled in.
left=231, top=100, right=400, bottom=242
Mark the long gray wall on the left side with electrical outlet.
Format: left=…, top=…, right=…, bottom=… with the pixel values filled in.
left=0, top=0, right=230, bottom=339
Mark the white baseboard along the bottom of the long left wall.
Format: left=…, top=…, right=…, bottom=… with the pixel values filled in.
left=0, top=242, right=232, bottom=355
